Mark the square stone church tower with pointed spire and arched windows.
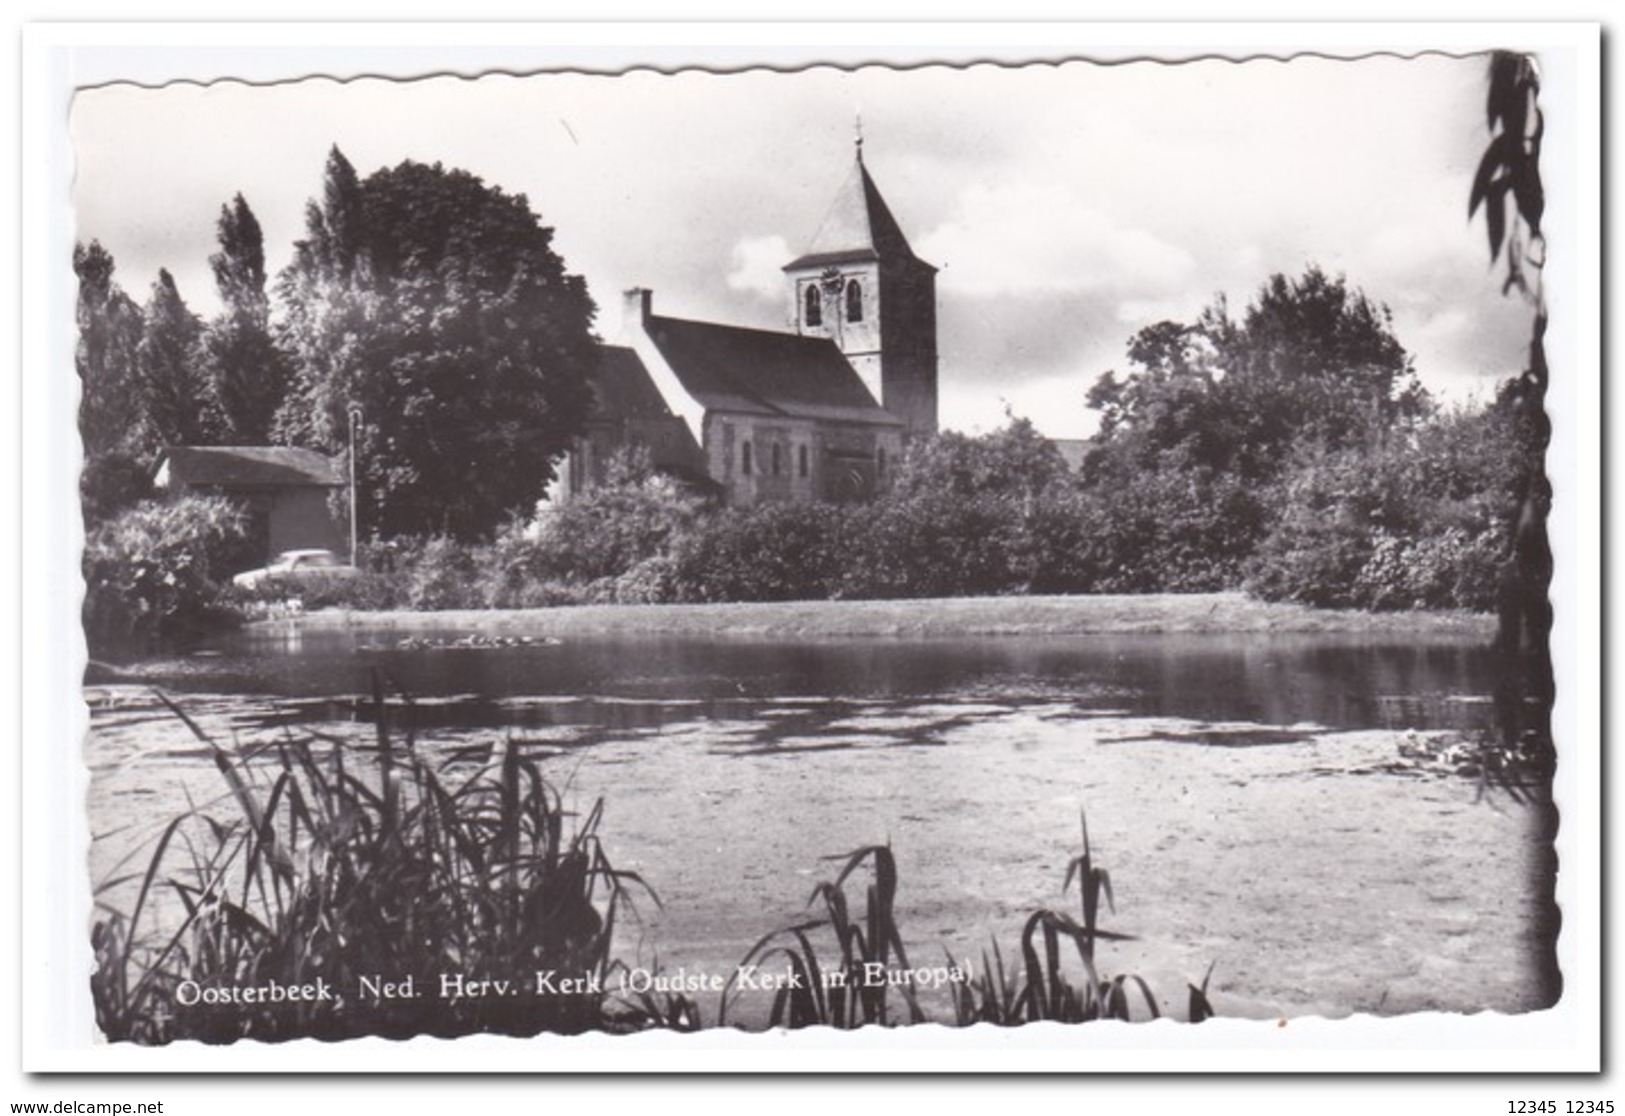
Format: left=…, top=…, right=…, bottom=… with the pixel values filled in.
left=785, top=135, right=936, bottom=435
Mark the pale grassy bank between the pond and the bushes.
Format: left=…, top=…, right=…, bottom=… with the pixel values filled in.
left=271, top=593, right=1495, bottom=640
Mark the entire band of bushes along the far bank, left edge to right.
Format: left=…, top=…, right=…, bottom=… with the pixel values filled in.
left=85, top=408, right=1532, bottom=647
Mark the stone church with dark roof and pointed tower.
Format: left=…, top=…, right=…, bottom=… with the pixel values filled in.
left=554, top=138, right=936, bottom=505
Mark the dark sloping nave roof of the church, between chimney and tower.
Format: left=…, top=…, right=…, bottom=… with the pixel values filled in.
left=645, top=315, right=902, bottom=426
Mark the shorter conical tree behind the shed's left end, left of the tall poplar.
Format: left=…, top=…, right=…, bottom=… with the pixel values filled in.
left=135, top=270, right=218, bottom=445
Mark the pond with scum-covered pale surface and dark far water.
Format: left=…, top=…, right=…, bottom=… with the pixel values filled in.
left=86, top=624, right=1557, bottom=1017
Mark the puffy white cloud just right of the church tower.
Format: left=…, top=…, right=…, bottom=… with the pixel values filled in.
left=917, top=184, right=1196, bottom=297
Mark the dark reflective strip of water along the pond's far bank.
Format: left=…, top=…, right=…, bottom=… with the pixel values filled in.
left=95, top=625, right=1492, bottom=746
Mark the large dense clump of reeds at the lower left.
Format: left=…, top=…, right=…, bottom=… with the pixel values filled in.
left=91, top=681, right=685, bottom=1043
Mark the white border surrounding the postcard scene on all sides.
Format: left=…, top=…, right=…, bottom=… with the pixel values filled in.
left=16, top=23, right=1602, bottom=1072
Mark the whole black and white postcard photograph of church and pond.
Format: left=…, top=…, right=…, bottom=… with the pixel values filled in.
left=22, top=19, right=1601, bottom=1069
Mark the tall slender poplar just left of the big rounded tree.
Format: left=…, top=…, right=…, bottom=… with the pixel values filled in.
left=202, top=193, right=288, bottom=445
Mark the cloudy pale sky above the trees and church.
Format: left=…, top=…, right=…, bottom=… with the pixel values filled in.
left=70, top=55, right=1529, bottom=437
